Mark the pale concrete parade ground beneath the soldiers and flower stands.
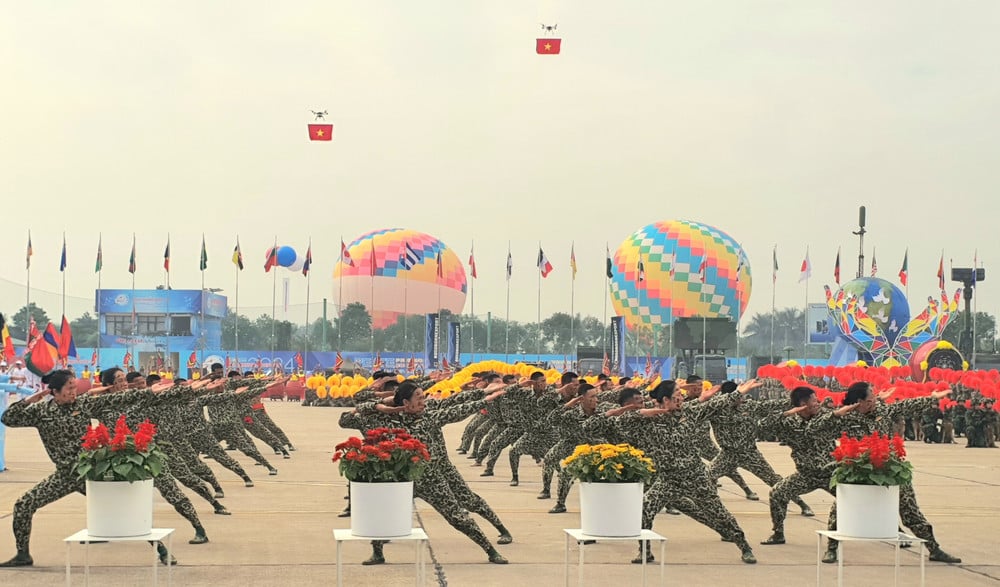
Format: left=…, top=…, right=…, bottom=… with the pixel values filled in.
left=0, top=402, right=1000, bottom=587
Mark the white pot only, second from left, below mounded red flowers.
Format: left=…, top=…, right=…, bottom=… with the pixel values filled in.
left=351, top=481, right=413, bottom=538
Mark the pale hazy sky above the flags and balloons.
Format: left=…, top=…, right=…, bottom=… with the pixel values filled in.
left=0, top=0, right=1000, bottom=330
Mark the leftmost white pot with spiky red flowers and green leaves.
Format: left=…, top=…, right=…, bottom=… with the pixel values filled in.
left=74, top=414, right=167, bottom=538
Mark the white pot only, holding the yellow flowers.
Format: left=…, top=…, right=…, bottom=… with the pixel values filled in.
left=580, top=483, right=642, bottom=537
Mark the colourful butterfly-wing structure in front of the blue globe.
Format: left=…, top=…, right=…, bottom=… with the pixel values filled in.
left=823, top=285, right=962, bottom=367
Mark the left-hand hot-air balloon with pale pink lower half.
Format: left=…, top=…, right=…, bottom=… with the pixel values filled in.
left=333, top=228, right=466, bottom=328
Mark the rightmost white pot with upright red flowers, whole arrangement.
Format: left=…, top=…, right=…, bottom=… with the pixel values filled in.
left=830, top=431, right=913, bottom=538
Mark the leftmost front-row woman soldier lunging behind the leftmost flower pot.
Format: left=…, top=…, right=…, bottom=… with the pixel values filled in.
left=0, top=370, right=208, bottom=567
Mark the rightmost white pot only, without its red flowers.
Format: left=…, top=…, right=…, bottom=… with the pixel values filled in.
left=837, top=483, right=899, bottom=538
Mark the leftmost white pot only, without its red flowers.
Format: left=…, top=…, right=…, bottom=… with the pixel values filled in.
left=87, top=479, right=153, bottom=538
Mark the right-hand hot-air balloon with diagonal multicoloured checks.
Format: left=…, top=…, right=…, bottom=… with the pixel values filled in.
left=611, top=220, right=752, bottom=328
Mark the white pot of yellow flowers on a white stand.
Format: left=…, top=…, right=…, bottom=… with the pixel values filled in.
left=562, top=444, right=656, bottom=537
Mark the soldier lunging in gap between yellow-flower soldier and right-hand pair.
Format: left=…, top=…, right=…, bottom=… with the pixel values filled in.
left=708, top=381, right=815, bottom=516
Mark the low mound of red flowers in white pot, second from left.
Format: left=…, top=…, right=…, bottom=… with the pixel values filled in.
left=333, top=428, right=431, bottom=538
